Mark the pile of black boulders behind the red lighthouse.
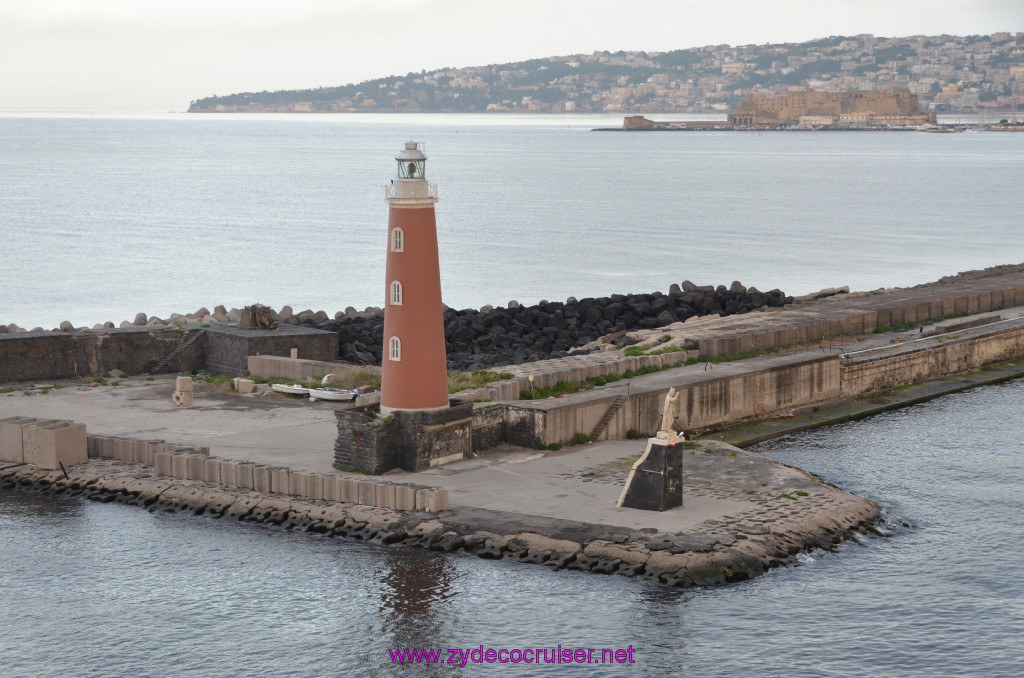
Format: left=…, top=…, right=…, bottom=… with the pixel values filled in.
left=299, top=281, right=793, bottom=370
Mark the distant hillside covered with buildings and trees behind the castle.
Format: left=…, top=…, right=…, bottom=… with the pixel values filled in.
left=188, top=33, right=1024, bottom=114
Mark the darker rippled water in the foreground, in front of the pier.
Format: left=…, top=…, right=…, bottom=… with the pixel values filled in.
left=0, top=381, right=1024, bottom=678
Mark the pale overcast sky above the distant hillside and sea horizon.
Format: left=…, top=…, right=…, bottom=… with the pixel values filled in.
left=0, top=0, right=1024, bottom=111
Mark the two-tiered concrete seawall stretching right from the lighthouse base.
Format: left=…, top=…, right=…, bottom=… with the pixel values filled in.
left=463, top=266, right=1024, bottom=450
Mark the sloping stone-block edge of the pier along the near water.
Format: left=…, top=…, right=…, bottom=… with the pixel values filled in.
left=0, top=443, right=879, bottom=587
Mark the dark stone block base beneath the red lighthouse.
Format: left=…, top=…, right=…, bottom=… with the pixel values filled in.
left=334, top=400, right=473, bottom=475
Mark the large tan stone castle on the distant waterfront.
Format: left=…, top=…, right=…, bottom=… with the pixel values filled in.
left=729, top=89, right=935, bottom=128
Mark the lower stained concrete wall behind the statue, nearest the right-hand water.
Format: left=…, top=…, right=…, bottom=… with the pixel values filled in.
left=505, top=317, right=1024, bottom=447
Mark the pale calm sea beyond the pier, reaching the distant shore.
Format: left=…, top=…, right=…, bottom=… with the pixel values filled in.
left=0, top=113, right=1024, bottom=329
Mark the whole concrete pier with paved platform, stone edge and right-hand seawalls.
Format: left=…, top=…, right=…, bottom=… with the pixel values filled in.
left=6, top=271, right=1024, bottom=585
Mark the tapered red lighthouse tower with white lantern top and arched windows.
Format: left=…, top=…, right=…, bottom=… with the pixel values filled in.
left=381, top=141, right=449, bottom=415
